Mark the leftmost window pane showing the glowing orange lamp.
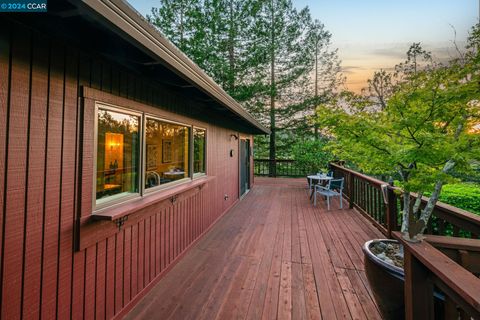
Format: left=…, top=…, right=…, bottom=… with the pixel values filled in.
left=96, top=109, right=140, bottom=204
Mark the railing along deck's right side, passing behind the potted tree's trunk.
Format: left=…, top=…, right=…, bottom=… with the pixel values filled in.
left=330, top=164, right=480, bottom=238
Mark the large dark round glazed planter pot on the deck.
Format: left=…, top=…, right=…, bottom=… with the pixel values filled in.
left=363, top=239, right=405, bottom=320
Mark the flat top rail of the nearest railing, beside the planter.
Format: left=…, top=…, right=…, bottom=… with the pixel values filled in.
left=392, top=232, right=480, bottom=311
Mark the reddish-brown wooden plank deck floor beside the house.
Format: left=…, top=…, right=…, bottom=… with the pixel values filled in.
left=126, top=178, right=382, bottom=319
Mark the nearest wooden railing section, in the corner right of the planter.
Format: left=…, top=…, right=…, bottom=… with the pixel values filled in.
left=393, top=232, right=480, bottom=320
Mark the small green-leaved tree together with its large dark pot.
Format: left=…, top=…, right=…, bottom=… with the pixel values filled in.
left=317, top=25, right=480, bottom=319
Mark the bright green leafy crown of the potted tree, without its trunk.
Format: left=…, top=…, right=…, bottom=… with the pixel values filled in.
left=318, top=37, right=480, bottom=192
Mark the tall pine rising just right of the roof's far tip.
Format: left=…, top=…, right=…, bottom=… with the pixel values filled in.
left=255, top=0, right=318, bottom=166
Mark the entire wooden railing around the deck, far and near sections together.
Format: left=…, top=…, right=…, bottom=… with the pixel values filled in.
left=255, top=160, right=480, bottom=319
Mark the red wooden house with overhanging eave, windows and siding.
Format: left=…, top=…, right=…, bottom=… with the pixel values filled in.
left=0, top=0, right=268, bottom=319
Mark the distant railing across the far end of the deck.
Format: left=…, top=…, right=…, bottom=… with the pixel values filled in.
left=254, top=159, right=315, bottom=177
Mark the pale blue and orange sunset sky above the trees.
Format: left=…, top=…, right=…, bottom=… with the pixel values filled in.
left=129, top=0, right=480, bottom=91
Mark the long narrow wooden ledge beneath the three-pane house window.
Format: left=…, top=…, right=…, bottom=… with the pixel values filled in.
left=92, top=176, right=214, bottom=221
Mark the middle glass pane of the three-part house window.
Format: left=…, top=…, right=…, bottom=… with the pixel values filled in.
left=145, top=118, right=190, bottom=189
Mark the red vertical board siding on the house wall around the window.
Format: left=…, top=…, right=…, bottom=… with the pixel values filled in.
left=0, top=21, right=248, bottom=320
